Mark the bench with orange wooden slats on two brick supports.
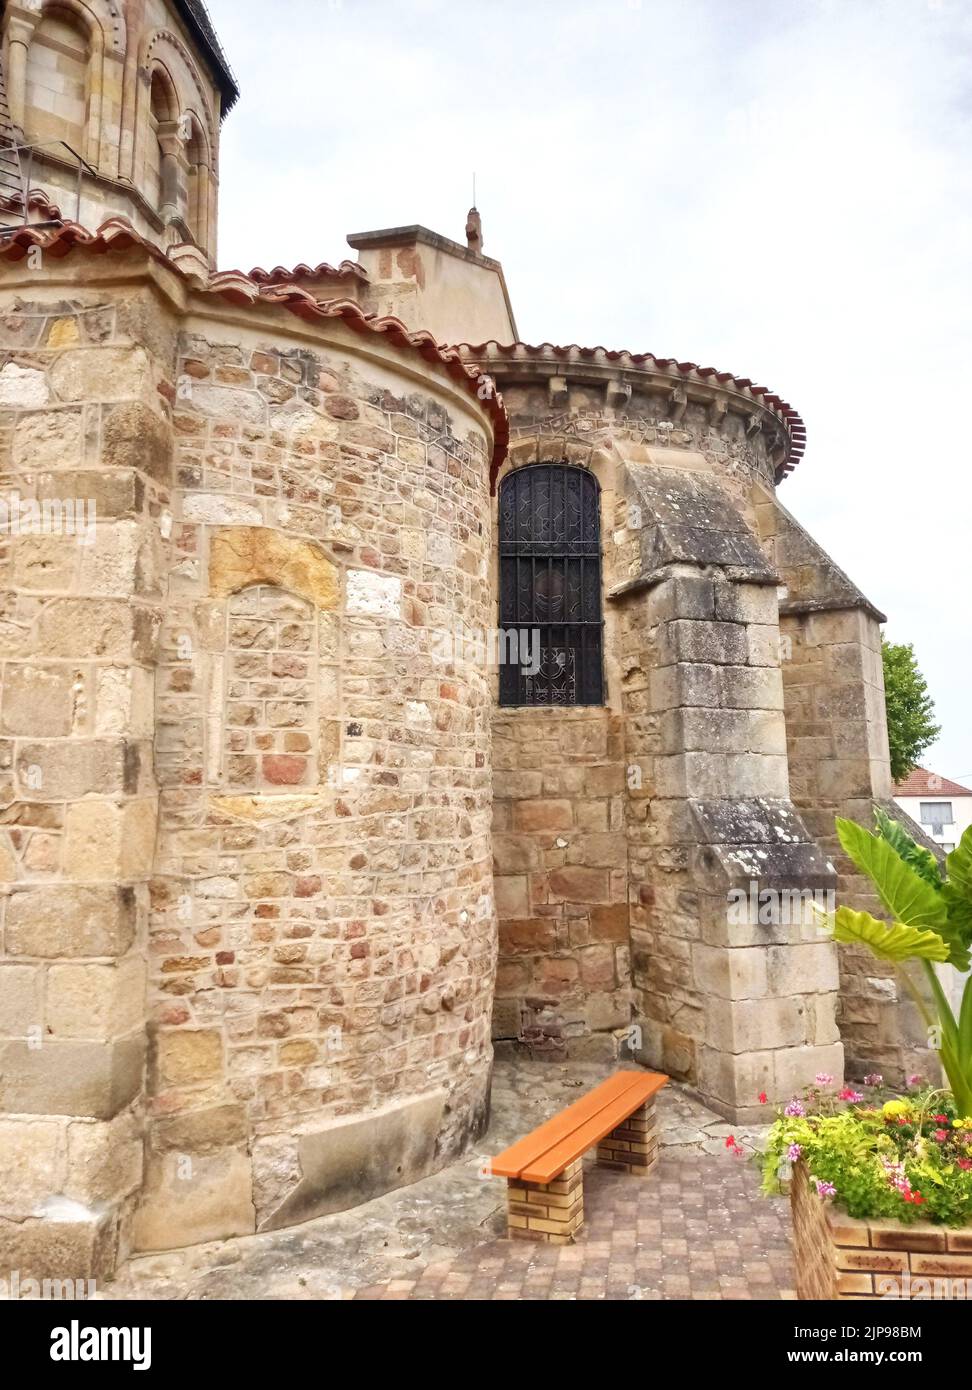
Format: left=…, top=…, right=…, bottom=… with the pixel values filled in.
left=489, top=1072, right=667, bottom=1245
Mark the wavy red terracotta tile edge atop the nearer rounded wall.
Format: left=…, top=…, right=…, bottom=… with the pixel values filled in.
left=0, top=217, right=509, bottom=482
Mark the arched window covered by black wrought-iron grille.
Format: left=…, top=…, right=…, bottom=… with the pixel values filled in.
left=499, top=463, right=604, bottom=705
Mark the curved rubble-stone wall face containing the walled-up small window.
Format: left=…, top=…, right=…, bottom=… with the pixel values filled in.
left=138, top=309, right=495, bottom=1247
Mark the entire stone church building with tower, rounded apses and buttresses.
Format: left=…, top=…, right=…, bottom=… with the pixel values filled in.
left=0, top=0, right=928, bottom=1277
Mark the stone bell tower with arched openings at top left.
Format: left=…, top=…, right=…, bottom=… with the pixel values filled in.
left=0, top=0, right=239, bottom=265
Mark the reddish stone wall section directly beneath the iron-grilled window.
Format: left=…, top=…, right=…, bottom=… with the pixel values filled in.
left=492, top=709, right=630, bottom=1056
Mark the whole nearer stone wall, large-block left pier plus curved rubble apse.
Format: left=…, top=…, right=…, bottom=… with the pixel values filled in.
left=0, top=250, right=495, bottom=1276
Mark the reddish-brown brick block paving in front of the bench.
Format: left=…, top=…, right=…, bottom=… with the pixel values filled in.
left=355, top=1151, right=795, bottom=1301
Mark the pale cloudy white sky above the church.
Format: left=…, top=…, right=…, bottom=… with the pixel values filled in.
left=210, top=0, right=972, bottom=781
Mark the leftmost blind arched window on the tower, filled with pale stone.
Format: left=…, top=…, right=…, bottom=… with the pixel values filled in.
left=25, top=7, right=90, bottom=156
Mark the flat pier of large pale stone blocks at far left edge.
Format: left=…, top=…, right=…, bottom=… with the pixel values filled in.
left=0, top=282, right=174, bottom=1279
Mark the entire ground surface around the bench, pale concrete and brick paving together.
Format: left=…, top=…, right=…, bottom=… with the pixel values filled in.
left=110, top=1058, right=794, bottom=1300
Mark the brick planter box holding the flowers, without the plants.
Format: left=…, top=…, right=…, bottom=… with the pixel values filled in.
left=790, top=1163, right=972, bottom=1300
